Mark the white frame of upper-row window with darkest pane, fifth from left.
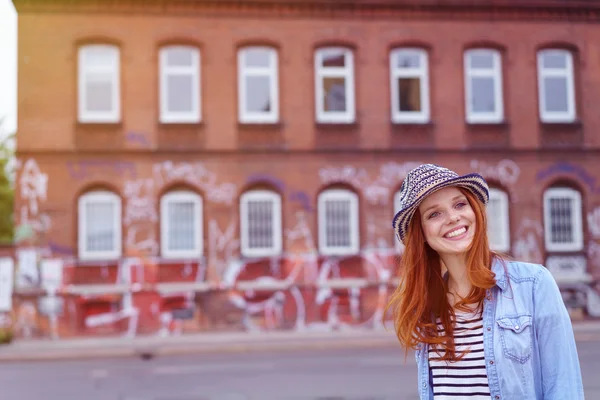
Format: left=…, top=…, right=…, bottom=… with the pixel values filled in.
left=390, top=47, right=430, bottom=124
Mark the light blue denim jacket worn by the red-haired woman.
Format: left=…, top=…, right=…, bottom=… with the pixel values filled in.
left=416, top=260, right=584, bottom=400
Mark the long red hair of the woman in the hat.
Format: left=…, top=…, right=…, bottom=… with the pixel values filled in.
left=386, top=188, right=498, bottom=361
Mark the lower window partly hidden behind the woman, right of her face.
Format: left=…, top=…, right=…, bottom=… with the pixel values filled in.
left=487, top=188, right=510, bottom=252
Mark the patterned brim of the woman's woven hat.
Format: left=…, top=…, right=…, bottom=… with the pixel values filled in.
left=393, top=173, right=489, bottom=243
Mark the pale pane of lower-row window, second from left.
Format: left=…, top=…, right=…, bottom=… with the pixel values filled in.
left=167, top=201, right=196, bottom=251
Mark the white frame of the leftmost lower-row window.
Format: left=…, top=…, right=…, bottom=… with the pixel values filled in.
left=77, top=191, right=122, bottom=260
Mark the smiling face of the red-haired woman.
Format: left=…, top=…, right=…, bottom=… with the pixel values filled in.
left=418, top=187, right=475, bottom=256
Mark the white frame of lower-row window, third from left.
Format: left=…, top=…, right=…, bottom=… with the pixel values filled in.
left=240, top=190, right=282, bottom=257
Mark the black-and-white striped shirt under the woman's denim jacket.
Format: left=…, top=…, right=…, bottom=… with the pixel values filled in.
left=429, top=312, right=491, bottom=400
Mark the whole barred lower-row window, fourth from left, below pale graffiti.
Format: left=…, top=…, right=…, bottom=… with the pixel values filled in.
left=318, top=189, right=360, bottom=255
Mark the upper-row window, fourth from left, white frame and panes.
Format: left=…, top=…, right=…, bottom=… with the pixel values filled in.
left=315, top=47, right=355, bottom=123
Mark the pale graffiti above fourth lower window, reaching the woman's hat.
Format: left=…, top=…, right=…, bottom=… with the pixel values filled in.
left=319, top=162, right=422, bottom=205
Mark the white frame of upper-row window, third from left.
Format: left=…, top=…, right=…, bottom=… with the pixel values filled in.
left=238, top=46, right=279, bottom=124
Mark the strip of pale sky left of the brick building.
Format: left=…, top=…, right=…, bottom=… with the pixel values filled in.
left=0, top=0, right=17, bottom=138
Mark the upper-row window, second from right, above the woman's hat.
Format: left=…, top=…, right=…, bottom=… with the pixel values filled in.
left=465, top=49, right=504, bottom=123
